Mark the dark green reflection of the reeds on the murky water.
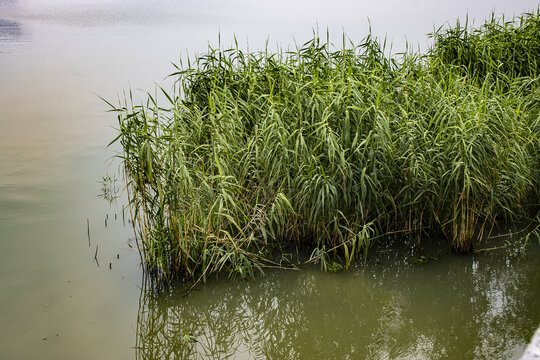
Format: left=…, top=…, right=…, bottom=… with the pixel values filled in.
left=136, top=249, right=540, bottom=359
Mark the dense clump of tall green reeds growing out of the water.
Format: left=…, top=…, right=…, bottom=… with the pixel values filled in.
left=107, top=13, right=540, bottom=280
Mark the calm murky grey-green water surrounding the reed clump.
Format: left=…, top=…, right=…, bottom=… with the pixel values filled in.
left=0, top=0, right=540, bottom=359
